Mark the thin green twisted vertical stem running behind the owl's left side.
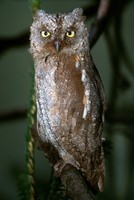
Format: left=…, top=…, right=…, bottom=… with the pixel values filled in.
left=25, top=0, right=40, bottom=200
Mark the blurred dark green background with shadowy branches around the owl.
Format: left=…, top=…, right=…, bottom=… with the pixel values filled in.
left=0, top=0, right=134, bottom=200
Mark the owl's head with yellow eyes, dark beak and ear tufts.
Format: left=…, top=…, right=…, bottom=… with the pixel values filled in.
left=30, top=8, right=89, bottom=56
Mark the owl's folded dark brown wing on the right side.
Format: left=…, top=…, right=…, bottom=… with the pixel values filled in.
left=80, top=58, right=106, bottom=191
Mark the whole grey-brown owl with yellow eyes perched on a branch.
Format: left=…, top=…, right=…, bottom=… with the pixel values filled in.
left=30, top=8, right=106, bottom=191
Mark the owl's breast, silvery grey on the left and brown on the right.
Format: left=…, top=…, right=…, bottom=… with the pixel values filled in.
left=36, top=54, right=85, bottom=136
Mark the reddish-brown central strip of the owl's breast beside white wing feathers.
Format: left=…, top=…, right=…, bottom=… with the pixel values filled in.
left=54, top=54, right=85, bottom=127
